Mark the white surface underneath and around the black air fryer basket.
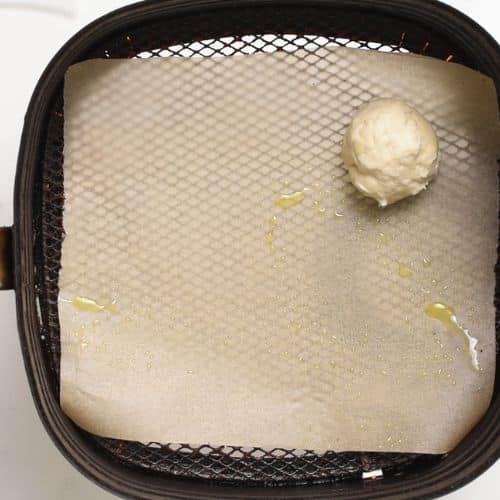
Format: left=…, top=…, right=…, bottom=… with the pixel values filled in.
left=0, top=0, right=500, bottom=500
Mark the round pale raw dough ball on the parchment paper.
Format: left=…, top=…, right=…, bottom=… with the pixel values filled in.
left=342, top=99, right=439, bottom=207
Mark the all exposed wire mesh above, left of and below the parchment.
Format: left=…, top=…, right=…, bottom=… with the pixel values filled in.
left=34, top=5, right=476, bottom=485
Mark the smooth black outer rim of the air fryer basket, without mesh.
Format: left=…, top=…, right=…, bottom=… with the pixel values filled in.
left=7, top=0, right=500, bottom=499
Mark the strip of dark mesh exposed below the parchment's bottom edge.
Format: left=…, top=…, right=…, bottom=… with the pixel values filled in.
left=93, top=438, right=434, bottom=486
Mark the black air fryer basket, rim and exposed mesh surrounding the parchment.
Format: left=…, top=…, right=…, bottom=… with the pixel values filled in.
left=6, top=0, right=500, bottom=498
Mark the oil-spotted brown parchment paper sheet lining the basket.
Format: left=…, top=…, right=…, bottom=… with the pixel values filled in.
left=59, top=49, right=498, bottom=453
